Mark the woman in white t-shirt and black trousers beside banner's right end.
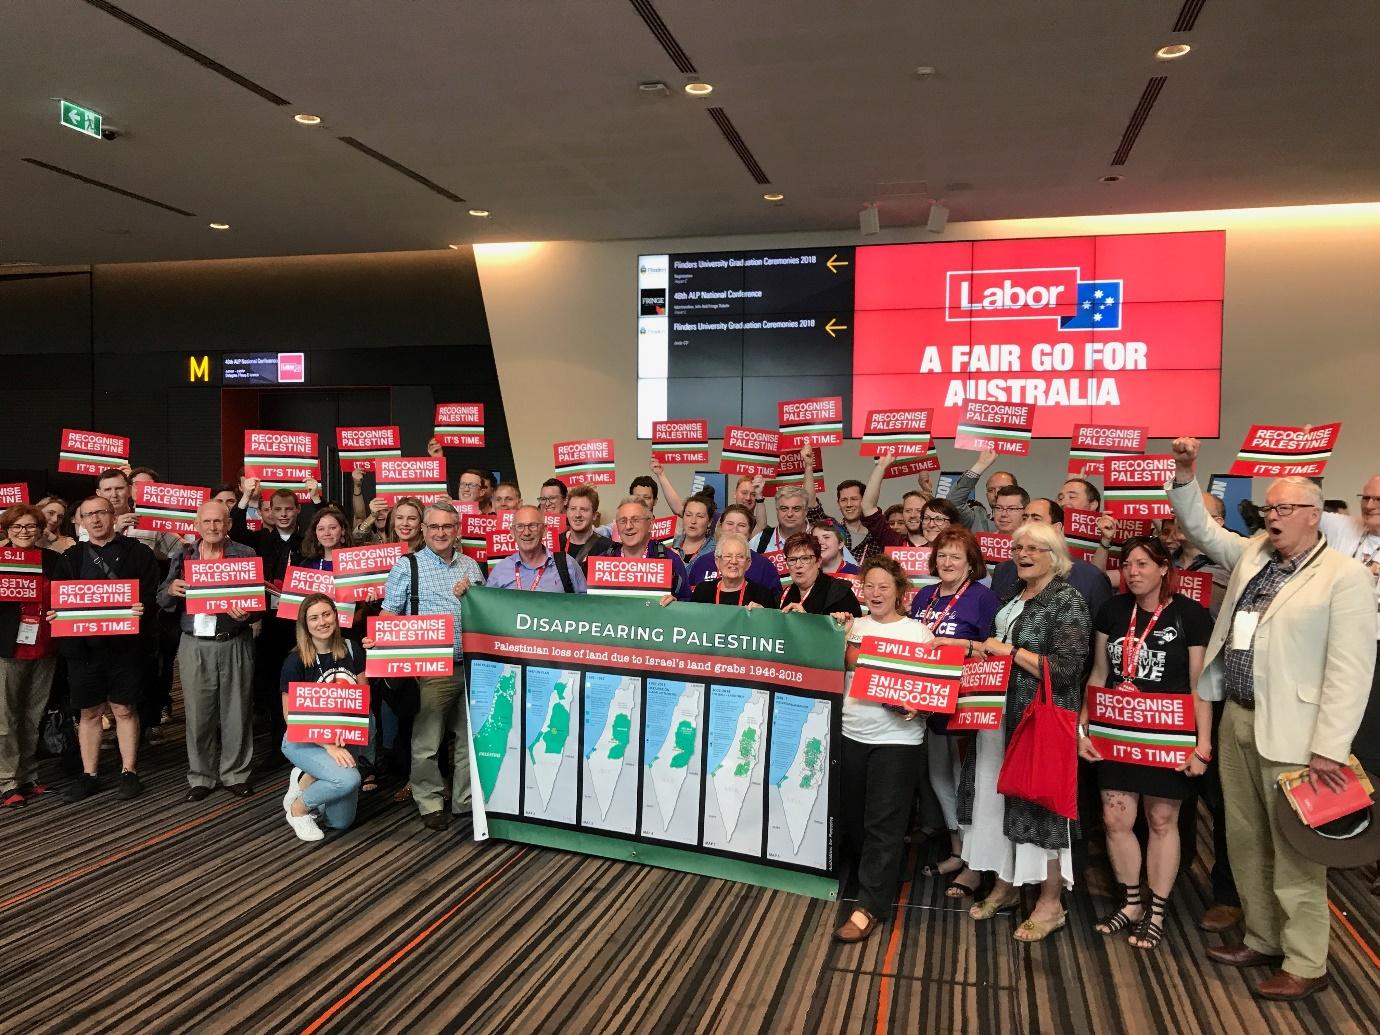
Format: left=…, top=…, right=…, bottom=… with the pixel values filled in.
left=834, top=556, right=934, bottom=941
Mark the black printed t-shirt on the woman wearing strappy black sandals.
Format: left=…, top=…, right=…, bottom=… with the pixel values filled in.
left=1096, top=593, right=1212, bottom=694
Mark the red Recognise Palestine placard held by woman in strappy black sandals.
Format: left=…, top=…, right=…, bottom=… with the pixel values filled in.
left=1087, top=686, right=1198, bottom=769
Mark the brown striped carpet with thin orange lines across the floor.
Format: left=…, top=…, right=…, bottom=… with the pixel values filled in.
left=0, top=726, right=1380, bottom=1035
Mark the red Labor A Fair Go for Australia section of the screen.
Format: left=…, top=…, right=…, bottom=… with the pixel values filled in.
left=850, top=230, right=1225, bottom=437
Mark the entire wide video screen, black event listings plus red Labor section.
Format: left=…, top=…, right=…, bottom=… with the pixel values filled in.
left=638, top=230, right=1225, bottom=437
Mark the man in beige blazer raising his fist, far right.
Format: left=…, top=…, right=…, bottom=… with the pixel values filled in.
left=1167, top=439, right=1376, bottom=999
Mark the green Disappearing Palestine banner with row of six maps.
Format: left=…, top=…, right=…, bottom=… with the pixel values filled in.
left=464, top=588, right=843, bottom=898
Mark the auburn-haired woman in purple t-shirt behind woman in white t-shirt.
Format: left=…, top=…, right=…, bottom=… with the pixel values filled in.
left=911, top=524, right=1002, bottom=898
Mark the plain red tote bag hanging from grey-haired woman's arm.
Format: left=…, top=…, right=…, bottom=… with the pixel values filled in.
left=996, top=661, right=1078, bottom=820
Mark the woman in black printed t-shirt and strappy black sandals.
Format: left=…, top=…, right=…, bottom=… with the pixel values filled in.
left=1078, top=535, right=1212, bottom=949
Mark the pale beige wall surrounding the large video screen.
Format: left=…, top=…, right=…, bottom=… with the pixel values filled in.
left=475, top=204, right=1380, bottom=512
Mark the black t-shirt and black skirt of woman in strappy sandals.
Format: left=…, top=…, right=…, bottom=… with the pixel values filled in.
left=1094, top=593, right=1212, bottom=802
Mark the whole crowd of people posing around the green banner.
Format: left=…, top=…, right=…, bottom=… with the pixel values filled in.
left=0, top=439, right=1380, bottom=999
